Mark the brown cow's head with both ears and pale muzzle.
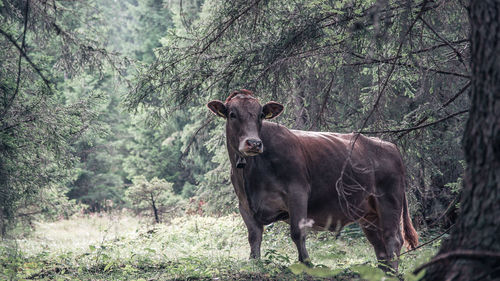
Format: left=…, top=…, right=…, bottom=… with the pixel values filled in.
left=207, top=90, right=283, bottom=157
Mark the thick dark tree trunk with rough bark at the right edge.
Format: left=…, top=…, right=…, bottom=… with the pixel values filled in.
left=425, top=0, right=500, bottom=280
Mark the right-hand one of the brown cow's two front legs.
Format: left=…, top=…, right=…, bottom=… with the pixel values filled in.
left=288, top=188, right=311, bottom=265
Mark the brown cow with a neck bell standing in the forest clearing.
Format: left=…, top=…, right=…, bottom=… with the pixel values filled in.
left=207, top=90, right=418, bottom=270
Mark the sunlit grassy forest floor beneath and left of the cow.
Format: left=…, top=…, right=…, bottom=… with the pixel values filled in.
left=0, top=214, right=439, bottom=280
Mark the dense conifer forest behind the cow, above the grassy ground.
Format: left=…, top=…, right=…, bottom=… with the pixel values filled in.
left=0, top=0, right=490, bottom=278
